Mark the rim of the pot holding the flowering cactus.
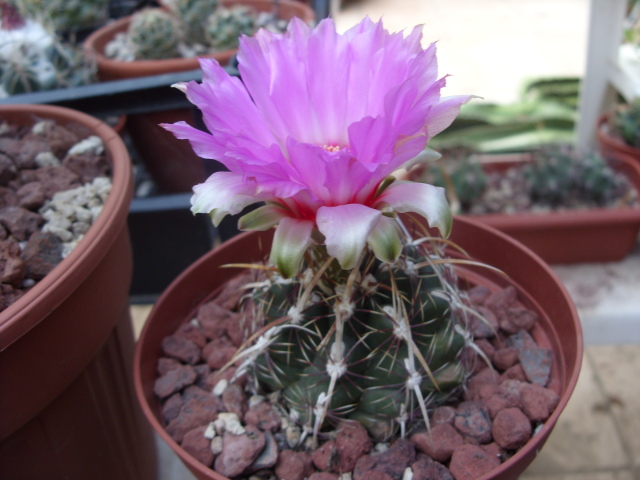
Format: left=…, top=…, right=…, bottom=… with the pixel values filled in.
left=134, top=217, right=584, bottom=480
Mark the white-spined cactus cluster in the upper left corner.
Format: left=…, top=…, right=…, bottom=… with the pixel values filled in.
left=0, top=1, right=96, bottom=96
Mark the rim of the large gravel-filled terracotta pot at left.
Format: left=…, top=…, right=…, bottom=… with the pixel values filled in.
left=0, top=105, right=133, bottom=351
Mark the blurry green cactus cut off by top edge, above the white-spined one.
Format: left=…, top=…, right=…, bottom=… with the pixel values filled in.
left=16, top=0, right=109, bottom=32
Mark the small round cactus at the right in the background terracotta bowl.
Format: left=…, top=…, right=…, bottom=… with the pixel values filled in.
left=206, top=5, right=256, bottom=51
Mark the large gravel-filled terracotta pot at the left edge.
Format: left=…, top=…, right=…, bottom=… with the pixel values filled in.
left=0, top=105, right=156, bottom=480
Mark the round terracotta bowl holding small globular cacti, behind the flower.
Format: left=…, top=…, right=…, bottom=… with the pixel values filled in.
left=83, top=0, right=315, bottom=81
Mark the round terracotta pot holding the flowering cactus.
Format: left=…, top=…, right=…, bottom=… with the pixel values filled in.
left=134, top=218, right=582, bottom=480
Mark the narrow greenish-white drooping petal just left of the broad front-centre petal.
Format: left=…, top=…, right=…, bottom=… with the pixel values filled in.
left=269, top=217, right=313, bottom=278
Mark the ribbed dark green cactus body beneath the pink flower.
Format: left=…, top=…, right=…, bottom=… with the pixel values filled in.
left=234, top=234, right=473, bottom=440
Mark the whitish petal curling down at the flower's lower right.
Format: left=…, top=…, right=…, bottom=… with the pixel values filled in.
left=374, top=181, right=453, bottom=237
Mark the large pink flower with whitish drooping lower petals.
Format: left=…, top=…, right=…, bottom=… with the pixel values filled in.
left=165, top=18, right=470, bottom=277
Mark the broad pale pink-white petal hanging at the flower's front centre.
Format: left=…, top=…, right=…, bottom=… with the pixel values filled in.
left=316, top=203, right=382, bottom=270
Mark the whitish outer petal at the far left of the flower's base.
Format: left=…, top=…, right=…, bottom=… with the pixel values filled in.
left=191, top=172, right=261, bottom=227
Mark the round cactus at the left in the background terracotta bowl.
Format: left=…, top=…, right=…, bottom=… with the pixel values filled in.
left=127, top=8, right=181, bottom=60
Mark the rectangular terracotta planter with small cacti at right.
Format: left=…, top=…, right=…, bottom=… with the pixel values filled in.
left=410, top=155, right=640, bottom=264
